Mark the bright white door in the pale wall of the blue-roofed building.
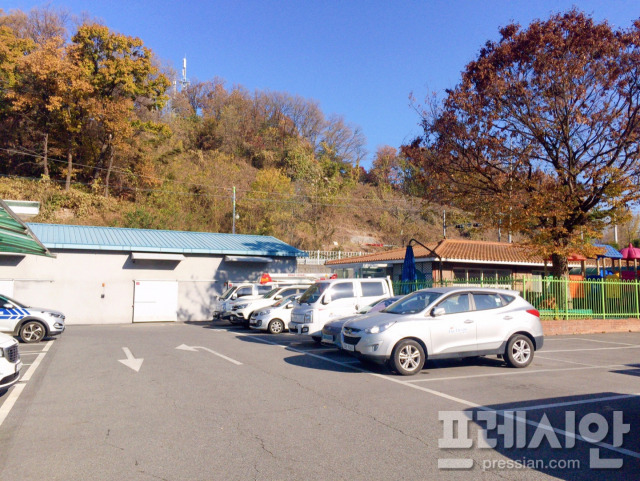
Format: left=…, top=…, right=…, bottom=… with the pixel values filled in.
left=133, top=281, right=178, bottom=322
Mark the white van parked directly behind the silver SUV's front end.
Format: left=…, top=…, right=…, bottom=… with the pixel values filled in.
left=289, top=277, right=393, bottom=342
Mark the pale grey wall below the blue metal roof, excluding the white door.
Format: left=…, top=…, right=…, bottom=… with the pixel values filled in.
left=0, top=250, right=296, bottom=324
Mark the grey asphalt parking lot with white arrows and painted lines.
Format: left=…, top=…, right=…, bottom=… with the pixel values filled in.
left=0, top=323, right=640, bottom=481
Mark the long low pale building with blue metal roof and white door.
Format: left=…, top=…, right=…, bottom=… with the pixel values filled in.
left=0, top=223, right=306, bottom=324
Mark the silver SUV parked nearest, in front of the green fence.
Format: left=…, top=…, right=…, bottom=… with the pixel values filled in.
left=342, top=287, right=544, bottom=375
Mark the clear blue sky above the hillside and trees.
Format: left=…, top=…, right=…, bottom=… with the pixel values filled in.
left=5, top=0, right=640, bottom=167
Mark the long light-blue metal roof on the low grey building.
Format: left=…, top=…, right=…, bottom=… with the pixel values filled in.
left=27, top=223, right=307, bottom=257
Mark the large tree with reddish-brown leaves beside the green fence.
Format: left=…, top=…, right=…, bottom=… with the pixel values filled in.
left=403, top=9, right=640, bottom=277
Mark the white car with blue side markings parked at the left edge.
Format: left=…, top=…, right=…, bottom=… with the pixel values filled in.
left=0, top=295, right=65, bottom=343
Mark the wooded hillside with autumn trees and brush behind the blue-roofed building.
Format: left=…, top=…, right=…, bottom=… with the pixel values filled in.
left=0, top=8, right=476, bottom=250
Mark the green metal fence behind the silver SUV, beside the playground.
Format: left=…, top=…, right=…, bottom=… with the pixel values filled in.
left=393, top=277, right=640, bottom=319
